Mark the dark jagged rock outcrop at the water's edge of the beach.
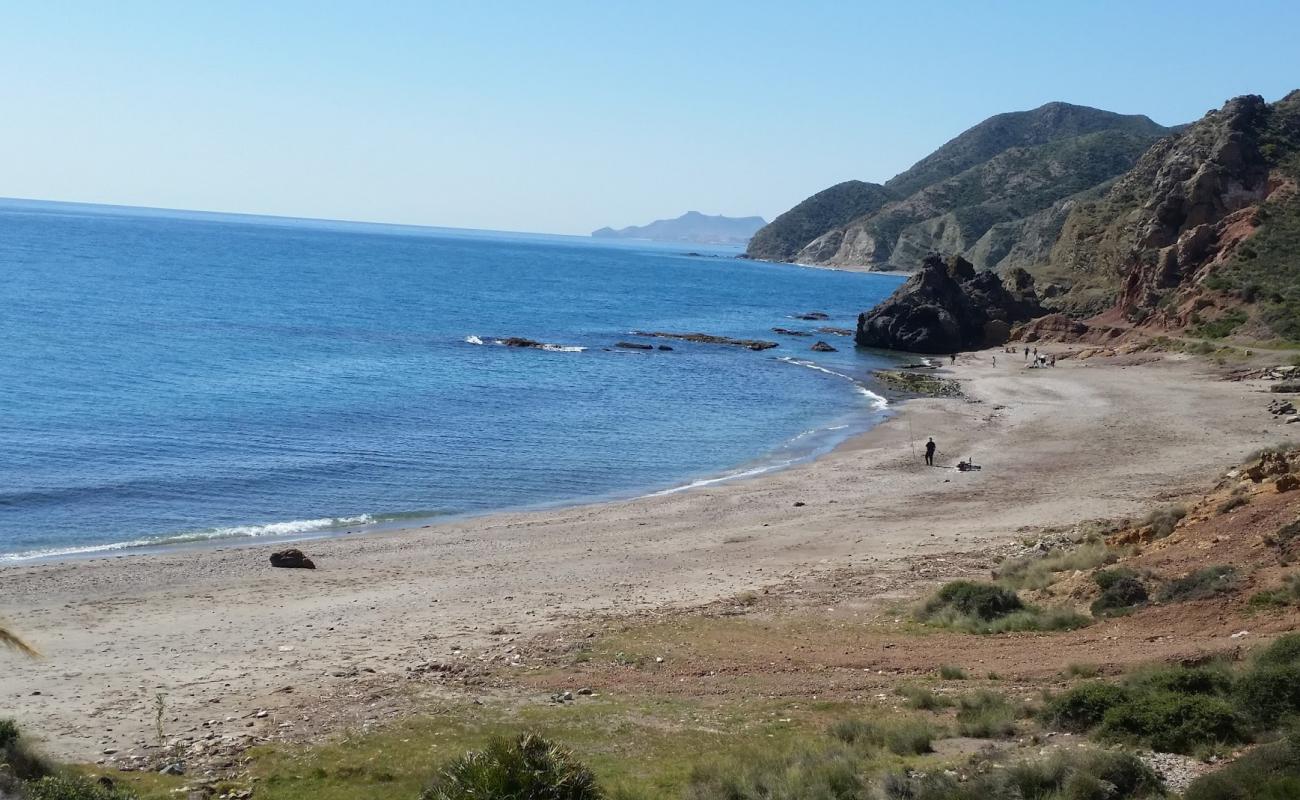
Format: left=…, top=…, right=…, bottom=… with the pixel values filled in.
left=854, top=255, right=1041, bottom=354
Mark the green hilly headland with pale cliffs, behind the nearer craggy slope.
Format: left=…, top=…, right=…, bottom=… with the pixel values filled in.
left=748, top=103, right=1170, bottom=269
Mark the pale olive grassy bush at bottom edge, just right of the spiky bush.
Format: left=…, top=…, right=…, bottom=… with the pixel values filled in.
left=686, top=741, right=870, bottom=800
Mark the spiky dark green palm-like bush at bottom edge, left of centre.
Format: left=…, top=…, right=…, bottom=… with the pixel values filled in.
left=418, top=734, right=602, bottom=800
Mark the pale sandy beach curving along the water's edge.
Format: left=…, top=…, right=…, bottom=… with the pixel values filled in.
left=0, top=353, right=1284, bottom=758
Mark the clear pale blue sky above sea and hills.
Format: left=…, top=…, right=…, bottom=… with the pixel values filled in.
left=0, top=0, right=1300, bottom=233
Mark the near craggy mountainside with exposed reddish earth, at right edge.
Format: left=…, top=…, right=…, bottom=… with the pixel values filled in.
left=1035, top=91, right=1300, bottom=341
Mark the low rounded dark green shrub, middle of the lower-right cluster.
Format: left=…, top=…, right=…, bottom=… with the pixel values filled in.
left=1097, top=691, right=1245, bottom=753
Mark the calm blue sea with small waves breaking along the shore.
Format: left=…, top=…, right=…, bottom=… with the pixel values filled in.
left=0, top=200, right=900, bottom=562
